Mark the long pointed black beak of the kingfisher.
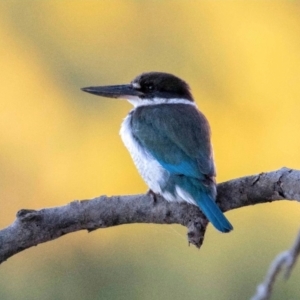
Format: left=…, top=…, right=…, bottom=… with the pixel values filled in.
left=81, top=84, right=143, bottom=98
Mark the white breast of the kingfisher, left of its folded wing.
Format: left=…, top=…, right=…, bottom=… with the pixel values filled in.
left=120, top=114, right=169, bottom=194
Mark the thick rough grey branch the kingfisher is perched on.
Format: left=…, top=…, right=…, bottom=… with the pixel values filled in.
left=0, top=168, right=300, bottom=263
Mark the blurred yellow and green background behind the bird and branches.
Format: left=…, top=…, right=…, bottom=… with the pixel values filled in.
left=0, top=0, right=300, bottom=300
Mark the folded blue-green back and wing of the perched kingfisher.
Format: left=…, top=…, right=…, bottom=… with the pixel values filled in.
left=131, top=104, right=215, bottom=179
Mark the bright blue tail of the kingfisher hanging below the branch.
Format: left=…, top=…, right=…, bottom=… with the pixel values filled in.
left=196, top=193, right=233, bottom=232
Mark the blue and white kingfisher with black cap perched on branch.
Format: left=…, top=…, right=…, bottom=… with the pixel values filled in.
left=82, top=72, right=233, bottom=232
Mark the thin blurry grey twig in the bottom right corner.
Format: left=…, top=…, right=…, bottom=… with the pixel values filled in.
left=251, top=231, right=300, bottom=300
